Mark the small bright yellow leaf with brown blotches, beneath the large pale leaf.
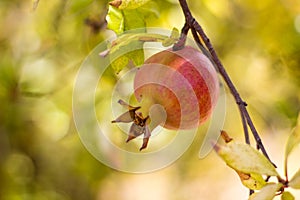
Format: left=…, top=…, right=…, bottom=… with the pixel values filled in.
left=237, top=171, right=267, bottom=190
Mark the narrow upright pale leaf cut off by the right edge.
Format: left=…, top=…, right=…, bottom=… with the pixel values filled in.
left=284, top=113, right=300, bottom=175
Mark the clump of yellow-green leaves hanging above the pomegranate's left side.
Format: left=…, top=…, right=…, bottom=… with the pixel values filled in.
left=105, top=0, right=163, bottom=73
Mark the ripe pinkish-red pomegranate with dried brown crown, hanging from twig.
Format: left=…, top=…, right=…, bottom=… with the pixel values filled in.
left=113, top=46, right=219, bottom=150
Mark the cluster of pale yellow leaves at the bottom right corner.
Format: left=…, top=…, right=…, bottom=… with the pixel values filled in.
left=214, top=114, right=300, bottom=200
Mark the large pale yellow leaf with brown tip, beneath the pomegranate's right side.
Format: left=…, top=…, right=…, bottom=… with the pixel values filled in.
left=214, top=141, right=279, bottom=176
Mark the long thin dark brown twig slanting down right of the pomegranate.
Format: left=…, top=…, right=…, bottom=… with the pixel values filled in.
left=179, top=0, right=270, bottom=160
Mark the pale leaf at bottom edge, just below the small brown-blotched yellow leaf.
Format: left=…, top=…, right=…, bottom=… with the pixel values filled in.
left=249, top=183, right=282, bottom=200
